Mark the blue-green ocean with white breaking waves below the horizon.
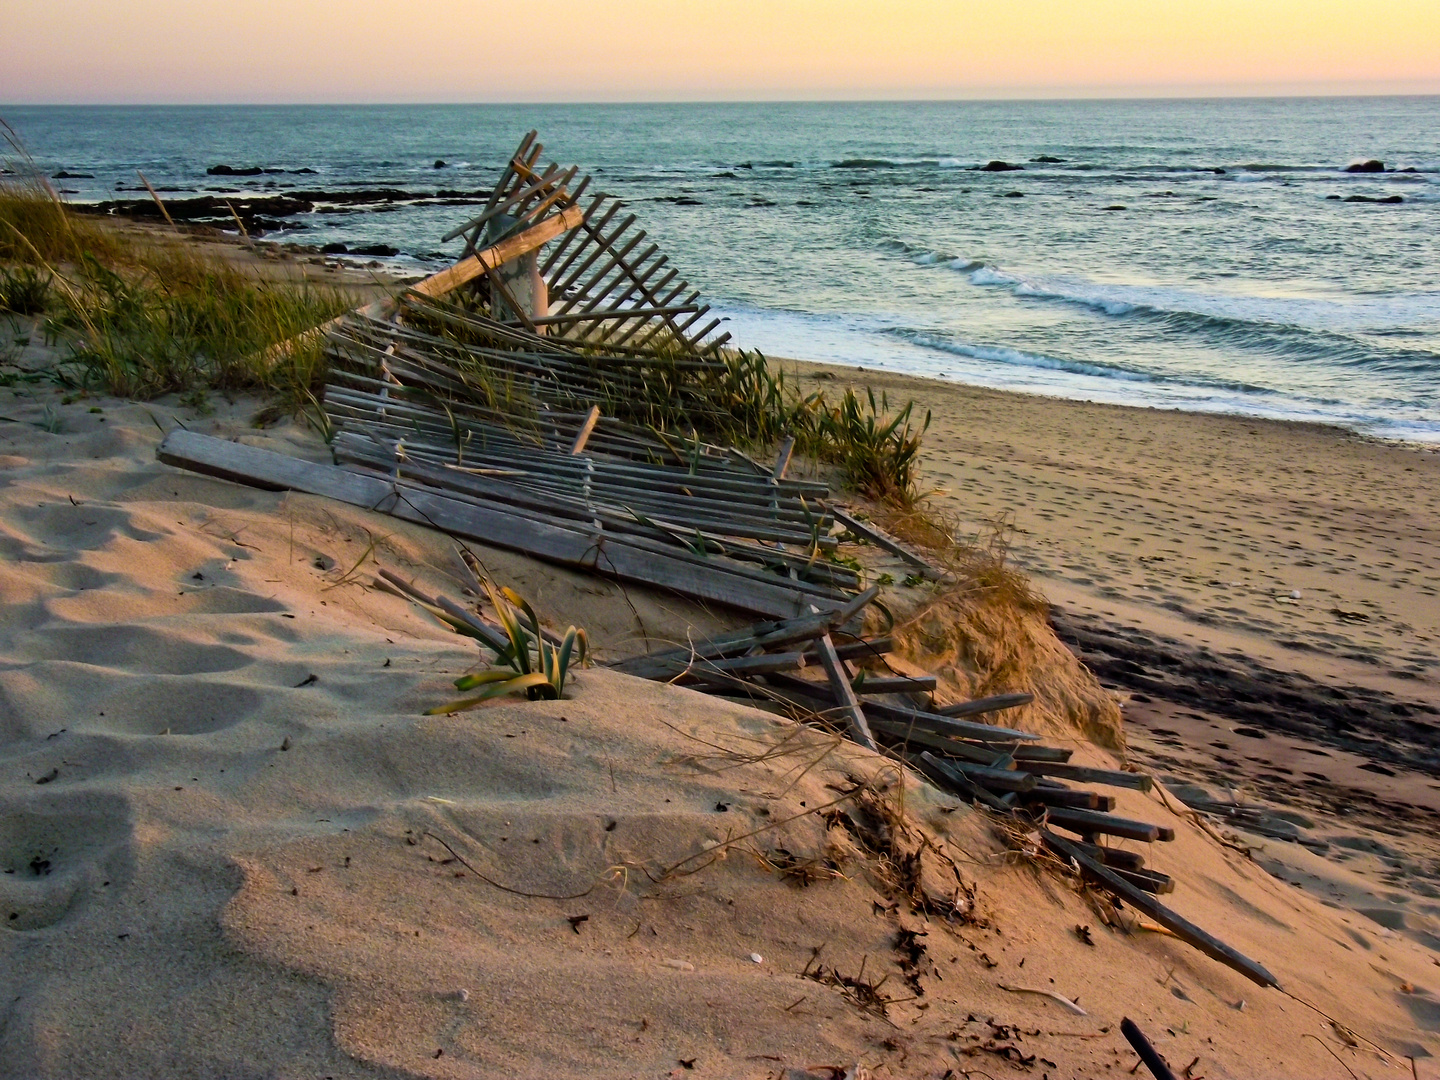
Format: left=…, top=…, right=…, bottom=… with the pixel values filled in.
left=0, top=98, right=1440, bottom=442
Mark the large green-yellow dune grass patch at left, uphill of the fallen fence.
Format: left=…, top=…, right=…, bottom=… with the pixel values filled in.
left=0, top=121, right=356, bottom=410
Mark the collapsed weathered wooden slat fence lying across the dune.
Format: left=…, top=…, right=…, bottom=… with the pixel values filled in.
left=158, top=132, right=1277, bottom=986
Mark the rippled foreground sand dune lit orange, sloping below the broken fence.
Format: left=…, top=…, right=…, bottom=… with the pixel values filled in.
left=0, top=352, right=1440, bottom=1080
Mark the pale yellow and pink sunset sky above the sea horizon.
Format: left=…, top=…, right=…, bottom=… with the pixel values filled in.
left=0, top=0, right=1440, bottom=104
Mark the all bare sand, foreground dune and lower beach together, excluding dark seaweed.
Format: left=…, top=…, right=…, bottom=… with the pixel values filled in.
left=0, top=280, right=1440, bottom=1080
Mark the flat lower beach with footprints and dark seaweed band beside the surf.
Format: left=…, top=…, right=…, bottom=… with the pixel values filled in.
left=799, top=364, right=1440, bottom=948
